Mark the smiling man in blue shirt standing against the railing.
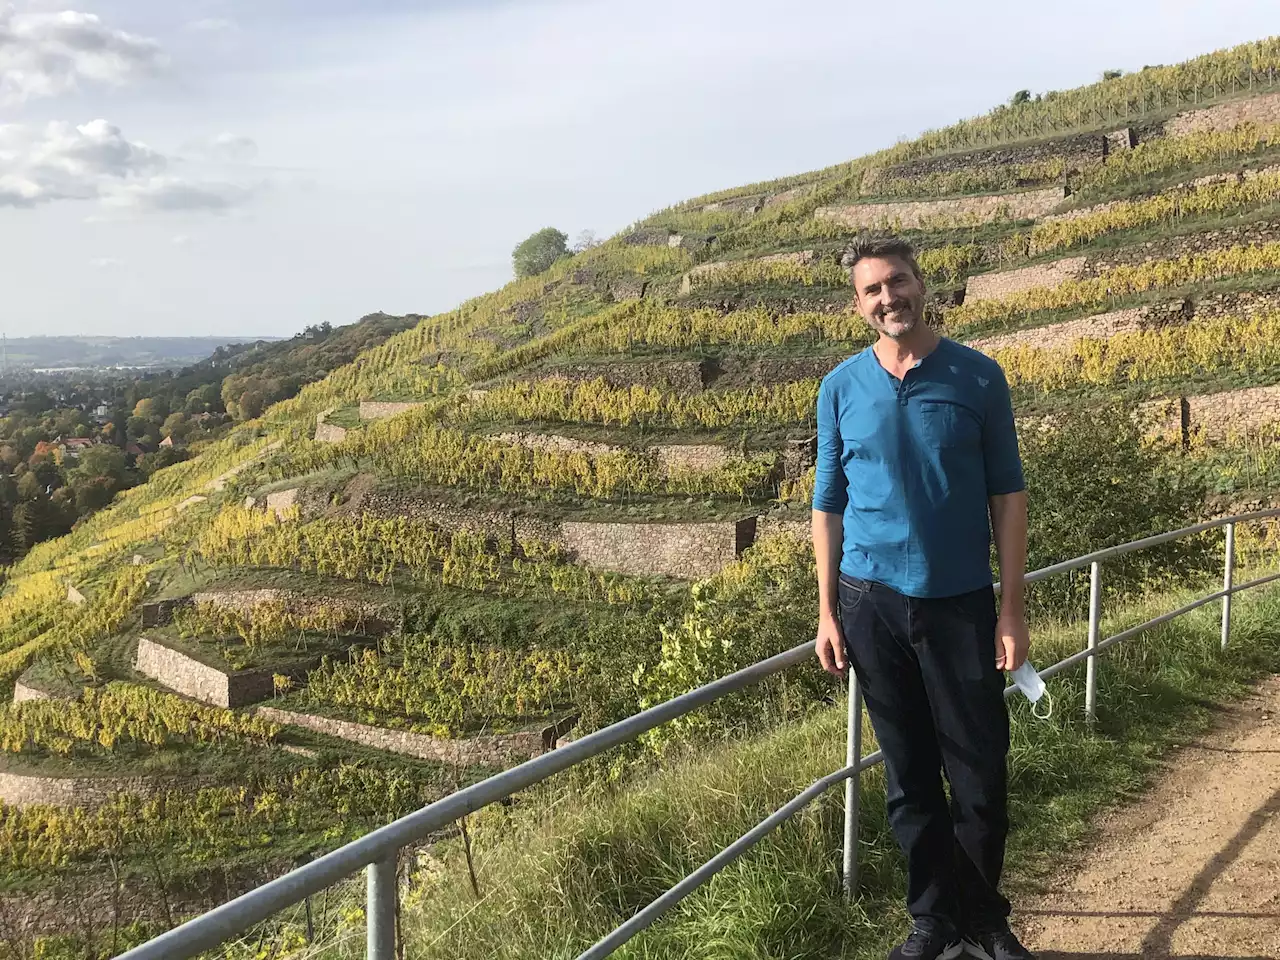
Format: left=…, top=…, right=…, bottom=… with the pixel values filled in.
left=813, top=239, right=1033, bottom=960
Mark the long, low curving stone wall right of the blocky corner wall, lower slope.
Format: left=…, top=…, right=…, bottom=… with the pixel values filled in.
left=255, top=707, right=573, bottom=767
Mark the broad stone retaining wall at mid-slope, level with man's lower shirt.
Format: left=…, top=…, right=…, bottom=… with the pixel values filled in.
left=561, top=517, right=755, bottom=580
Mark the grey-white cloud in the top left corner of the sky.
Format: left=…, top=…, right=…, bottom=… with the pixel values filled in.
left=0, top=6, right=166, bottom=104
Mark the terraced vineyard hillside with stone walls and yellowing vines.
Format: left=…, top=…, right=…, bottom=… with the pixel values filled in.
left=0, top=40, right=1280, bottom=956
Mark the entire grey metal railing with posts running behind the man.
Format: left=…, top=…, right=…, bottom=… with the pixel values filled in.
left=118, top=509, right=1280, bottom=960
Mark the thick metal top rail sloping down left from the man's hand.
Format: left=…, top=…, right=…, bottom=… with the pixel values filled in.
left=119, top=640, right=814, bottom=960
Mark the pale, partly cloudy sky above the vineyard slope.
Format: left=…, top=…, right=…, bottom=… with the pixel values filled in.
left=0, top=0, right=1280, bottom=338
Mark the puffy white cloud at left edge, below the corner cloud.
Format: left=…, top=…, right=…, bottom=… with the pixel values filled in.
left=0, top=120, right=251, bottom=212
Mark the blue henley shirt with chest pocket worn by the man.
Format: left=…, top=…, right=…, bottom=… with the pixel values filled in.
left=813, top=338, right=1024, bottom=596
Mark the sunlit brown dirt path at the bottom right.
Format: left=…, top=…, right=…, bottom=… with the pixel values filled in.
left=1015, top=677, right=1280, bottom=960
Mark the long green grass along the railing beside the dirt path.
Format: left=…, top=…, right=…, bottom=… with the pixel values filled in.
left=262, top=575, right=1280, bottom=960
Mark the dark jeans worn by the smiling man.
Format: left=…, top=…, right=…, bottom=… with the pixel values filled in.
left=840, top=575, right=1009, bottom=933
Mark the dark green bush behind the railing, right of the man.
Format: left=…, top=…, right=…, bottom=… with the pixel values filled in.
left=1020, top=407, right=1216, bottom=613
